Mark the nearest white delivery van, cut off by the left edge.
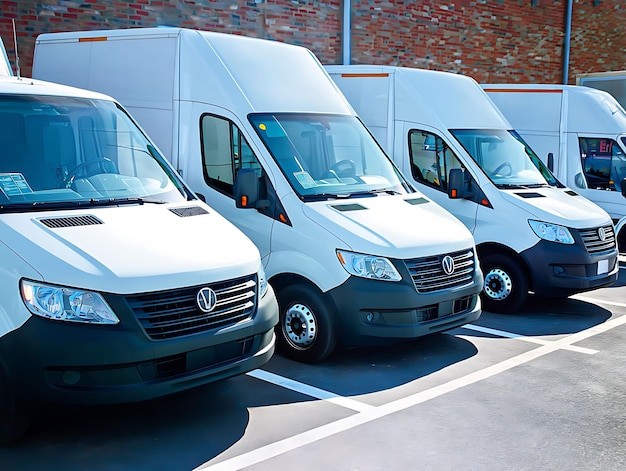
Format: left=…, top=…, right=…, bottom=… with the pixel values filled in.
left=0, top=52, right=278, bottom=443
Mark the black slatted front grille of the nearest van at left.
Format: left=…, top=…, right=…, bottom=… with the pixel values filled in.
left=126, top=275, right=257, bottom=340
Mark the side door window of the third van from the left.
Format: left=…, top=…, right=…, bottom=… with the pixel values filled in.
left=409, top=130, right=462, bottom=191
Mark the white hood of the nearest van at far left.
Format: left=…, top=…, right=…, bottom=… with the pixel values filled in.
left=0, top=202, right=260, bottom=294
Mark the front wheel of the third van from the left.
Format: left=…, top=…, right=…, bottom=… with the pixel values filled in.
left=480, top=254, right=528, bottom=313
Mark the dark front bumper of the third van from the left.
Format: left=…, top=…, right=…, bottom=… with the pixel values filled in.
left=520, top=240, right=619, bottom=297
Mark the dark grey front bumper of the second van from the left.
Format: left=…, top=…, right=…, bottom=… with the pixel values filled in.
left=328, top=270, right=482, bottom=346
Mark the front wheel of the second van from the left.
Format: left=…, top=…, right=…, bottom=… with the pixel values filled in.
left=276, top=284, right=337, bottom=363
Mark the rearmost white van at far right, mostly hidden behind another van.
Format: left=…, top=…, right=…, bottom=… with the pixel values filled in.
left=483, top=84, right=626, bottom=252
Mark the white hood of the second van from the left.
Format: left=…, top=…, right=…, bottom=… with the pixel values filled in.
left=303, top=193, right=474, bottom=259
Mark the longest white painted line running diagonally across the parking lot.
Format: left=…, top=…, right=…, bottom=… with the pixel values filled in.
left=194, top=315, right=626, bottom=471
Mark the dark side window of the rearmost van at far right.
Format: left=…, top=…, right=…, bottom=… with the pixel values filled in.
left=578, top=137, right=626, bottom=191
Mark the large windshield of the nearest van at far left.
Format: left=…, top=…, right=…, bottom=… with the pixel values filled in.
left=0, top=95, right=188, bottom=211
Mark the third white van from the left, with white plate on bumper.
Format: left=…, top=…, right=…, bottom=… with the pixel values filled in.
left=327, top=66, right=619, bottom=312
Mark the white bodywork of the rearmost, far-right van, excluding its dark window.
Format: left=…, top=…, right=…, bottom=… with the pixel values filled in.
left=482, top=84, right=626, bottom=240
